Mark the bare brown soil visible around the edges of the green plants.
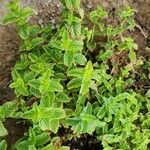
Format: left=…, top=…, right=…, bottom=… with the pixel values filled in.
left=0, top=0, right=150, bottom=149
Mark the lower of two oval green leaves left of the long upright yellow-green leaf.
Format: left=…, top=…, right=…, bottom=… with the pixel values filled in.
left=67, top=78, right=82, bottom=90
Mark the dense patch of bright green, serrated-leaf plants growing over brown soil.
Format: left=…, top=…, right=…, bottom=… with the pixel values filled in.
left=0, top=0, right=150, bottom=150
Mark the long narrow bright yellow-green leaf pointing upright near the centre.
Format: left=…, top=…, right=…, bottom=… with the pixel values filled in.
left=80, top=61, right=94, bottom=95
